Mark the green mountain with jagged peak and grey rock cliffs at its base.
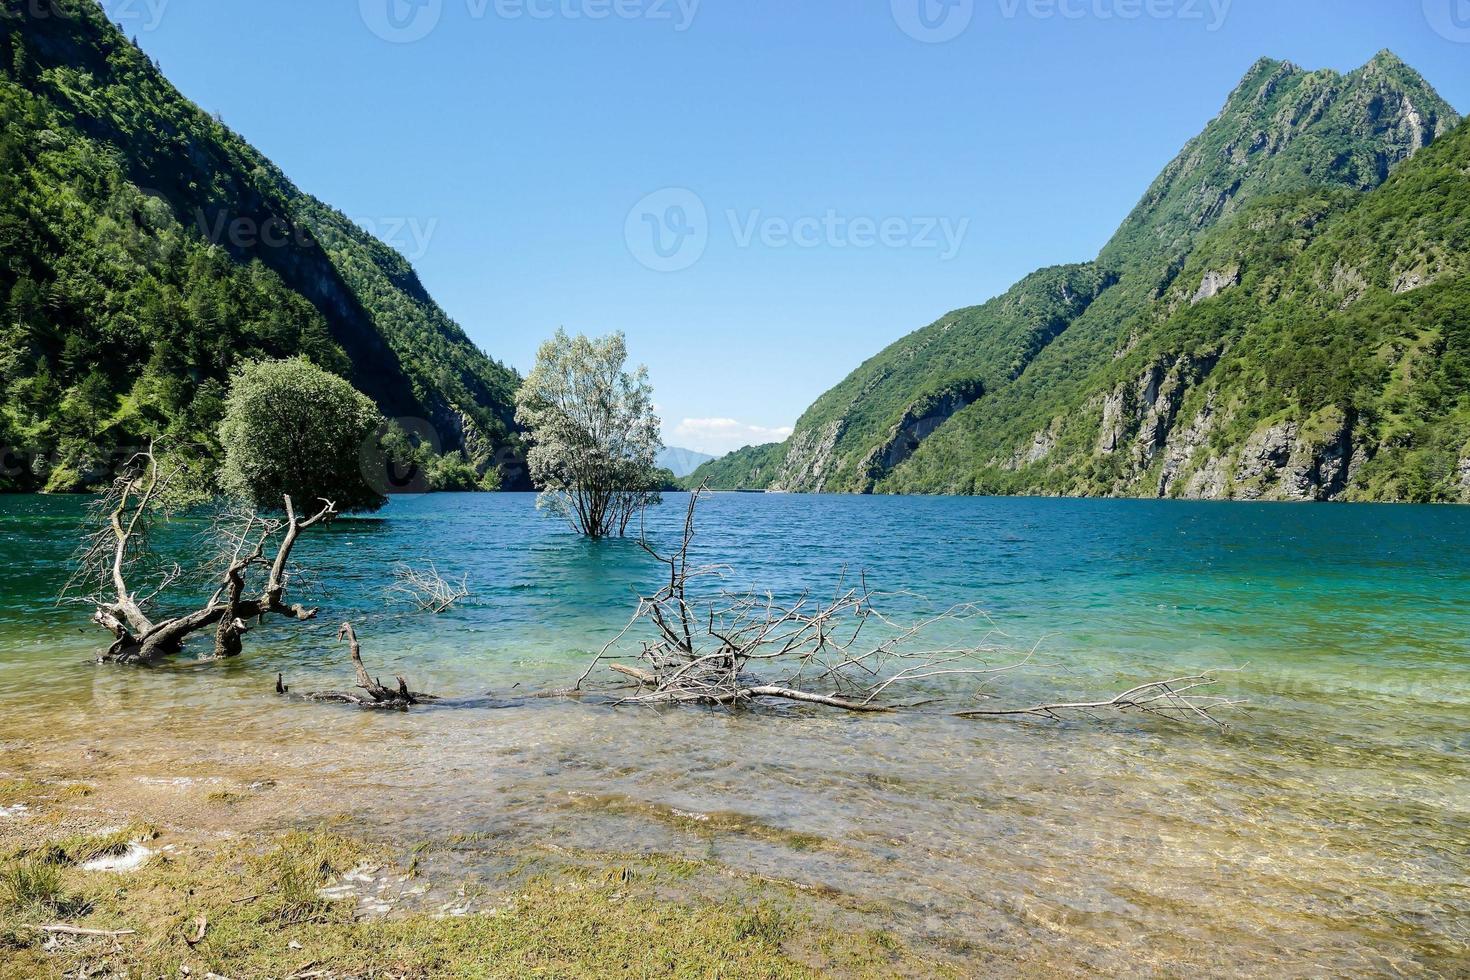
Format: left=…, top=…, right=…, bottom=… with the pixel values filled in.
left=691, top=51, right=1470, bottom=500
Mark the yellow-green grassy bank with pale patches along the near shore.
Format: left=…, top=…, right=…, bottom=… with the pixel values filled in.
left=0, top=780, right=944, bottom=980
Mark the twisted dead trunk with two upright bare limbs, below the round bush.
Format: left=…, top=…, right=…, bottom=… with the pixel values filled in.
left=65, top=447, right=337, bottom=664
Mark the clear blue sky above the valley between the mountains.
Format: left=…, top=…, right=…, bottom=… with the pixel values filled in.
left=103, top=0, right=1470, bottom=453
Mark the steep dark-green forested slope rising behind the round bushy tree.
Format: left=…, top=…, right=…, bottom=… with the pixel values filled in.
left=0, top=0, right=519, bottom=489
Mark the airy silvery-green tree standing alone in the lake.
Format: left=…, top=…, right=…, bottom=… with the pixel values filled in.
left=516, top=331, right=663, bottom=539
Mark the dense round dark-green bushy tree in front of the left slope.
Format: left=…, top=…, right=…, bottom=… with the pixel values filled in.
left=219, top=359, right=387, bottom=511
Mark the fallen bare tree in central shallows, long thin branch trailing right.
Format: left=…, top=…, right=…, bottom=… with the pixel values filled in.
left=564, top=488, right=1242, bottom=724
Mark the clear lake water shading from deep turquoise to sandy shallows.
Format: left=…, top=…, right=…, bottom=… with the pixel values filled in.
left=0, top=495, right=1470, bottom=974
